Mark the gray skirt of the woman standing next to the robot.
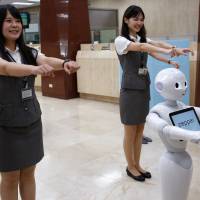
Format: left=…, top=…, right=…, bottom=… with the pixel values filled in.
left=119, top=88, right=150, bottom=125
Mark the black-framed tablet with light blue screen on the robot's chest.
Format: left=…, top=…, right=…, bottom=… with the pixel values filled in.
left=169, top=107, right=200, bottom=131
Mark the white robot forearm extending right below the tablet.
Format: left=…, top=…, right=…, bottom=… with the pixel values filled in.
left=163, top=125, right=200, bottom=143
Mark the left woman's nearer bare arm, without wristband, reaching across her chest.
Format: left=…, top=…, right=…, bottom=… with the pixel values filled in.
left=0, top=58, right=53, bottom=77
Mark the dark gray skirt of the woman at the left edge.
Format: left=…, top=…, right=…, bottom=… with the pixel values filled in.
left=0, top=120, right=44, bottom=172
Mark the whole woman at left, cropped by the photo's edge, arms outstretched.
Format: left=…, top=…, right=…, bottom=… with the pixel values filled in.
left=0, top=5, right=79, bottom=200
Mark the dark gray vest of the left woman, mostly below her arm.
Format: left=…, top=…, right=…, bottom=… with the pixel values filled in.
left=0, top=50, right=41, bottom=127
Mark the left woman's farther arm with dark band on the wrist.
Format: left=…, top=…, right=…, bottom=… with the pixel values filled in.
left=36, top=54, right=80, bottom=74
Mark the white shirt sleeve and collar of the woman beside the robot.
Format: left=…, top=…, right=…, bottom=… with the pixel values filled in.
left=115, top=35, right=151, bottom=55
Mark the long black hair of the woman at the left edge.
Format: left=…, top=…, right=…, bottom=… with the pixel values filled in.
left=0, top=4, right=36, bottom=65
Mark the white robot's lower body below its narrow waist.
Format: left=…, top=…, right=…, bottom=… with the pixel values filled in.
left=160, top=152, right=193, bottom=200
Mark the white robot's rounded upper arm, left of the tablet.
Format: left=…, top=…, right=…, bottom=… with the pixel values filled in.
left=146, top=112, right=169, bottom=132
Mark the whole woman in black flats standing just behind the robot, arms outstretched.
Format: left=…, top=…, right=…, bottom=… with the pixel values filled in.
left=115, top=5, right=191, bottom=181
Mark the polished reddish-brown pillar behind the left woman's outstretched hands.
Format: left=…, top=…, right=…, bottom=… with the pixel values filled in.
left=40, top=0, right=91, bottom=99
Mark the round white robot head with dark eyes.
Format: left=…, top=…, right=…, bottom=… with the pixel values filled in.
left=155, top=68, right=187, bottom=100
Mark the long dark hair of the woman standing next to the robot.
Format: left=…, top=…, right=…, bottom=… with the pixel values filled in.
left=121, top=5, right=146, bottom=42
